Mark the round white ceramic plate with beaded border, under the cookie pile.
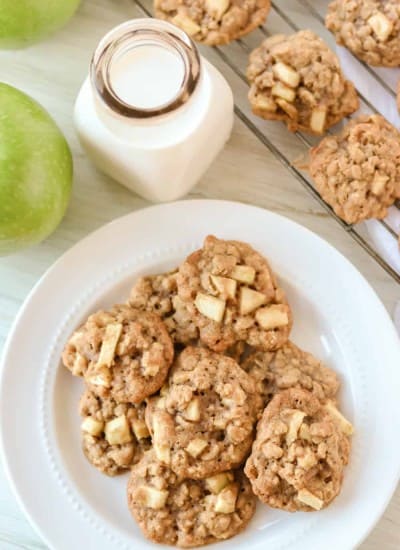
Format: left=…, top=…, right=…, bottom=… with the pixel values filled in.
left=0, top=200, right=400, bottom=550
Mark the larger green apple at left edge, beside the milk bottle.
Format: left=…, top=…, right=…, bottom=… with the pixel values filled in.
left=0, top=82, right=73, bottom=255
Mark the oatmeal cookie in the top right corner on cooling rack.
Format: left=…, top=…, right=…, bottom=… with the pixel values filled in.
left=325, top=0, right=400, bottom=67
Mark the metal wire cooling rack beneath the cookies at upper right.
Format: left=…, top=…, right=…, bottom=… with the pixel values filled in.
left=133, top=0, right=400, bottom=283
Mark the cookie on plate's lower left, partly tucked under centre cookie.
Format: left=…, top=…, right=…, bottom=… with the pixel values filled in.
left=79, top=389, right=150, bottom=476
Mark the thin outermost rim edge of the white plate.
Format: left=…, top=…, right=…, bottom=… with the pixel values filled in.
left=0, top=199, right=400, bottom=548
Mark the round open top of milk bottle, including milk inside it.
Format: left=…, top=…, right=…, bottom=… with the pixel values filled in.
left=90, top=19, right=201, bottom=119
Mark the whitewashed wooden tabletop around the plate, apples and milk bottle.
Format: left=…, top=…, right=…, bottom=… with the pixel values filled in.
left=0, top=0, right=400, bottom=550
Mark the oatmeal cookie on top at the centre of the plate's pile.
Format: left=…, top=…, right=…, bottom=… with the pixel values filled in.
left=146, top=347, right=259, bottom=479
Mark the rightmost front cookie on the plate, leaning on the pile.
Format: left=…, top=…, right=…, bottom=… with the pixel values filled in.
left=244, top=389, right=353, bottom=512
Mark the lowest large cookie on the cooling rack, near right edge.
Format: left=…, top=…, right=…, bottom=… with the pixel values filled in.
left=309, top=115, right=400, bottom=224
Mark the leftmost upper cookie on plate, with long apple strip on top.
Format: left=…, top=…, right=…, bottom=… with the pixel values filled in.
left=63, top=305, right=174, bottom=403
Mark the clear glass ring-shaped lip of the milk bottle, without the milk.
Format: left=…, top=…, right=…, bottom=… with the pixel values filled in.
left=90, top=18, right=201, bottom=119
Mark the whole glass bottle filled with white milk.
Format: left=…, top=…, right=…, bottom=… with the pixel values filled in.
left=75, top=19, right=233, bottom=205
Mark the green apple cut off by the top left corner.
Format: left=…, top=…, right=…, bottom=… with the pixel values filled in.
left=0, top=0, right=80, bottom=48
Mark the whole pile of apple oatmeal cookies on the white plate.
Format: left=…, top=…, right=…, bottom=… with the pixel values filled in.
left=63, top=236, right=352, bottom=547
